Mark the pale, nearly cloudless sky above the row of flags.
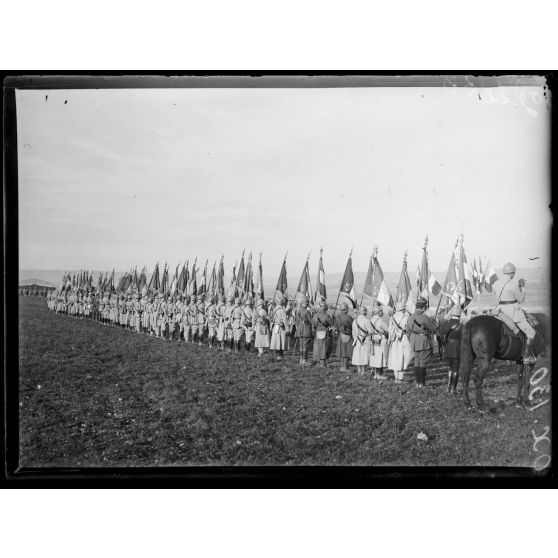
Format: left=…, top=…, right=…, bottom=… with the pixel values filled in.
left=16, top=83, right=552, bottom=275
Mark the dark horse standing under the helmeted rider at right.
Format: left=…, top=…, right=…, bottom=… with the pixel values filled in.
left=460, top=314, right=550, bottom=411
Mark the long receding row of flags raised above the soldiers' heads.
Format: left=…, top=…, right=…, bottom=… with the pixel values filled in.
left=60, top=234, right=498, bottom=316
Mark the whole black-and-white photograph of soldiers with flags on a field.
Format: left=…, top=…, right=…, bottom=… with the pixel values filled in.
left=5, top=74, right=552, bottom=475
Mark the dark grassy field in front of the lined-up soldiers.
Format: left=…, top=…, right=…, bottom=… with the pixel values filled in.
left=19, top=297, right=550, bottom=467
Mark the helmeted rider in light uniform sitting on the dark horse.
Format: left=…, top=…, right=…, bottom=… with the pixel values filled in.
left=496, top=262, right=536, bottom=364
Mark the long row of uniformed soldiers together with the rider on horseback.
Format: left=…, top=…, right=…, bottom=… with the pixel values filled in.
left=47, top=264, right=534, bottom=388
